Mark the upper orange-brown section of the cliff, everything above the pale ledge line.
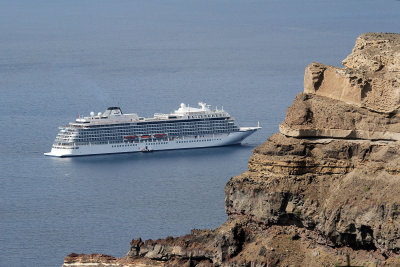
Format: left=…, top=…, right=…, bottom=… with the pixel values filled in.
left=279, top=33, right=400, bottom=141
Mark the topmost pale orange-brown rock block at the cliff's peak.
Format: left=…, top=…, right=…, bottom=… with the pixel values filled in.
left=304, top=33, right=400, bottom=113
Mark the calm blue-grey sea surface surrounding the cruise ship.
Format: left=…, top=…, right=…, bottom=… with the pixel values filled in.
left=0, top=0, right=400, bottom=266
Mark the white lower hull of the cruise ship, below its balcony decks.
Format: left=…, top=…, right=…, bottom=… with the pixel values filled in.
left=44, top=127, right=259, bottom=157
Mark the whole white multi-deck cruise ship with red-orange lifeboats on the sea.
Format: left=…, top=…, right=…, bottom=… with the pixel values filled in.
left=44, top=102, right=261, bottom=157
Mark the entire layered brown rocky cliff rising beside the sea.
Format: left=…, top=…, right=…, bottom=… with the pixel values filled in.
left=64, top=33, right=400, bottom=267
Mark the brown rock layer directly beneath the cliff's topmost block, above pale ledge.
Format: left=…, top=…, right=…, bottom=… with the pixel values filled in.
left=279, top=93, right=400, bottom=141
